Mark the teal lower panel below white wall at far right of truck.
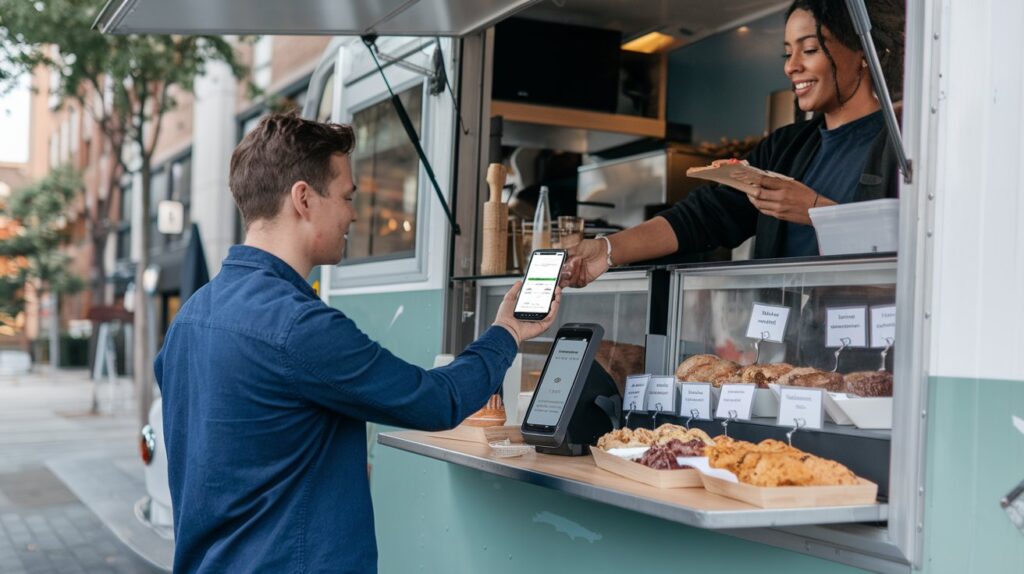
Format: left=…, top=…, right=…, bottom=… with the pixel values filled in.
left=923, top=377, right=1024, bottom=574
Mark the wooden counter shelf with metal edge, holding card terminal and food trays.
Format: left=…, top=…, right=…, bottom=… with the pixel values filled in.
left=377, top=431, right=889, bottom=529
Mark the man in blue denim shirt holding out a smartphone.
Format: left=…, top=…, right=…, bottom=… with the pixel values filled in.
left=156, top=115, right=559, bottom=573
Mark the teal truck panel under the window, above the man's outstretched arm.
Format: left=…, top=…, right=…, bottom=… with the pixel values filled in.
left=330, top=291, right=444, bottom=368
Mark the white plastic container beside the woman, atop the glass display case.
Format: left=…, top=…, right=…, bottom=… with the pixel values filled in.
left=807, top=200, right=899, bottom=255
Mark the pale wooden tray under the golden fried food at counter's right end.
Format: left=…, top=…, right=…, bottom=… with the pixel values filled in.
left=700, top=475, right=879, bottom=509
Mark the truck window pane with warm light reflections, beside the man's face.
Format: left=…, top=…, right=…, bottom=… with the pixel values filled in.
left=343, top=85, right=423, bottom=265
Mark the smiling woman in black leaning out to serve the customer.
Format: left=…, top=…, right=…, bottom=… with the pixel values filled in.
left=569, top=0, right=904, bottom=286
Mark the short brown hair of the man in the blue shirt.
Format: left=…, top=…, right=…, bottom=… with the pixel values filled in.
left=228, top=114, right=355, bottom=229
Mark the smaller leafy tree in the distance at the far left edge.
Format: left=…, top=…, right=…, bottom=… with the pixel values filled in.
left=0, top=167, right=82, bottom=362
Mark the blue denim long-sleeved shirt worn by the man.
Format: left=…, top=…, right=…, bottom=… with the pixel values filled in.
left=156, top=246, right=516, bottom=573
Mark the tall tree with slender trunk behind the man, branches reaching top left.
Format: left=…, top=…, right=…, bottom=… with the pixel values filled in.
left=0, top=0, right=246, bottom=421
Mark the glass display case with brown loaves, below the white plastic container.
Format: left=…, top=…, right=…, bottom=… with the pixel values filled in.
left=659, top=257, right=899, bottom=496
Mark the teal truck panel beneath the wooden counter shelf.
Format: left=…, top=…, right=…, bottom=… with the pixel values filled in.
left=373, top=445, right=863, bottom=574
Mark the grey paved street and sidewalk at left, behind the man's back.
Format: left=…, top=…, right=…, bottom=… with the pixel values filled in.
left=0, top=367, right=170, bottom=574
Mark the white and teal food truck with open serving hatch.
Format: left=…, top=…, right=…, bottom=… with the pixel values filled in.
left=97, top=0, right=1024, bottom=573
